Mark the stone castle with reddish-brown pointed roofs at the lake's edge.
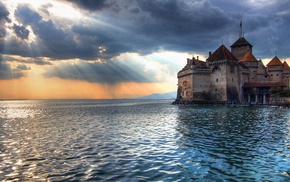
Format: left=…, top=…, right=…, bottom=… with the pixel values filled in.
left=176, top=30, right=290, bottom=104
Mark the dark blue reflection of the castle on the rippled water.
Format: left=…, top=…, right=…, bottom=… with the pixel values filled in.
left=177, top=107, right=290, bottom=181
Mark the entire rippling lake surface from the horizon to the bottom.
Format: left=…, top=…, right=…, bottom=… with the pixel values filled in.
left=0, top=100, right=290, bottom=181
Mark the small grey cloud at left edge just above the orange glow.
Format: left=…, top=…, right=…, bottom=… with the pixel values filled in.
left=0, top=61, right=24, bottom=80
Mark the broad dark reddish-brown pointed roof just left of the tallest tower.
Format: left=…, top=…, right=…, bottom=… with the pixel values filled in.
left=207, top=45, right=237, bottom=62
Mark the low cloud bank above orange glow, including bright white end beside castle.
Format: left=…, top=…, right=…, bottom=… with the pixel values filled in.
left=44, top=54, right=179, bottom=84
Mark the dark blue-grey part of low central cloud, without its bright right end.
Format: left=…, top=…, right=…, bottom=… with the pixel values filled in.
left=45, top=61, right=157, bottom=84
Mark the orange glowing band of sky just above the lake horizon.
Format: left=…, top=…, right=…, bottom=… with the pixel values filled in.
left=0, top=78, right=176, bottom=99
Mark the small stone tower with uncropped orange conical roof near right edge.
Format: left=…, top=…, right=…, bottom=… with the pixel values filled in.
left=267, top=56, right=284, bottom=82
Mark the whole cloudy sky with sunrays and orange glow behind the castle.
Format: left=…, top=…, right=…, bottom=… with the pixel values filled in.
left=0, top=0, right=290, bottom=99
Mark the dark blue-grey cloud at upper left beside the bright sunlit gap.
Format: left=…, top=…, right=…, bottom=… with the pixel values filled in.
left=10, top=5, right=112, bottom=60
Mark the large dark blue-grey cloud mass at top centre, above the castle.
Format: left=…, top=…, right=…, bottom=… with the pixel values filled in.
left=72, top=1, right=239, bottom=58
